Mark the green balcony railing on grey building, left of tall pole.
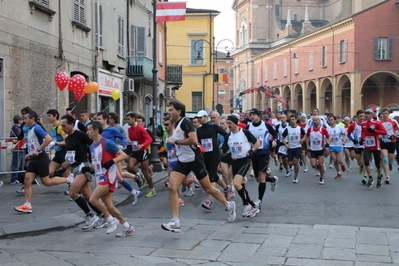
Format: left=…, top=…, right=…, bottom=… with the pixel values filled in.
left=126, top=55, right=153, bottom=79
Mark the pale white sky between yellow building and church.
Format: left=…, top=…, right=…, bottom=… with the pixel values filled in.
left=169, top=0, right=235, bottom=46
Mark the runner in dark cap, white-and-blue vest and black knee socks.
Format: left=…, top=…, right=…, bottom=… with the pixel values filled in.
left=247, top=108, right=278, bottom=208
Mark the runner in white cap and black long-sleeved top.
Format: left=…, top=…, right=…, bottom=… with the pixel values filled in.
left=196, top=110, right=230, bottom=211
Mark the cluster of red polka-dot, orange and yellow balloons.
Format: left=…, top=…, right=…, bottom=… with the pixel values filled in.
left=54, top=71, right=120, bottom=101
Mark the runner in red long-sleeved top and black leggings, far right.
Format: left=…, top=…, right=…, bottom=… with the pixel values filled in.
left=360, top=109, right=388, bottom=188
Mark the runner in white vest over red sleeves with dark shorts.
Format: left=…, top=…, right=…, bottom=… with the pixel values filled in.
left=305, top=115, right=330, bottom=185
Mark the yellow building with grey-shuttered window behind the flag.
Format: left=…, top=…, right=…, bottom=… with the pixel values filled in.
left=166, top=8, right=220, bottom=112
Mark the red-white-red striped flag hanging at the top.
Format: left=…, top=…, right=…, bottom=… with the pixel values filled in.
left=155, top=2, right=186, bottom=22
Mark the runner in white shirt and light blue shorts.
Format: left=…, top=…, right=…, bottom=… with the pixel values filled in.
left=327, top=115, right=347, bottom=179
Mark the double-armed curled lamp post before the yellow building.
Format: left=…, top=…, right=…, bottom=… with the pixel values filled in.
left=194, top=37, right=234, bottom=110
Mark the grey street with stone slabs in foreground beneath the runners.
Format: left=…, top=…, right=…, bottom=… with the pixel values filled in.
left=0, top=161, right=399, bottom=266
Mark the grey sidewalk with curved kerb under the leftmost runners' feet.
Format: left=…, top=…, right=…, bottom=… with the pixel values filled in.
left=0, top=171, right=167, bottom=239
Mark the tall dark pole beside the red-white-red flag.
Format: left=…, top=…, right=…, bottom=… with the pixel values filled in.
left=149, top=0, right=162, bottom=172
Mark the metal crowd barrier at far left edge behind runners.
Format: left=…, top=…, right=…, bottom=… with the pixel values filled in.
left=0, top=137, right=25, bottom=175
